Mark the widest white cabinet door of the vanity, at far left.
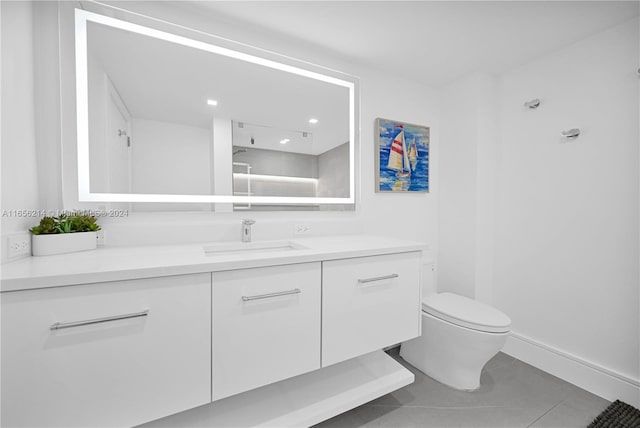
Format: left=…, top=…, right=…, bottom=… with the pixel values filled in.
left=1, top=273, right=211, bottom=427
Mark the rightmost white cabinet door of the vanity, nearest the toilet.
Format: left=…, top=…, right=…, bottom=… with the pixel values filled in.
left=322, top=252, right=421, bottom=367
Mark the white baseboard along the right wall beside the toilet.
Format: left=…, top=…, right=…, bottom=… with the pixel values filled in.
left=502, top=332, right=640, bottom=407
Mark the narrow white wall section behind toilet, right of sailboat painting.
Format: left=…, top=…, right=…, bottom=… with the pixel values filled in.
left=437, top=73, right=498, bottom=303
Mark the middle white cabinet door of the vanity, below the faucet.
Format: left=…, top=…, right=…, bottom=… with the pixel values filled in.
left=213, top=263, right=320, bottom=400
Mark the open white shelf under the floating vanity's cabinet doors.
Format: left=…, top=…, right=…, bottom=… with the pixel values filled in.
left=138, top=351, right=415, bottom=428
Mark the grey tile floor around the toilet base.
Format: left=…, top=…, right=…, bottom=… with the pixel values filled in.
left=314, top=349, right=609, bottom=428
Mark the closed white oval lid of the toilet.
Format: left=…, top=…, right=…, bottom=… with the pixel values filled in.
left=422, top=293, right=511, bottom=333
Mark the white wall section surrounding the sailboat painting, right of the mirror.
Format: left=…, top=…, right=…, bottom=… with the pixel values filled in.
left=358, top=70, right=440, bottom=249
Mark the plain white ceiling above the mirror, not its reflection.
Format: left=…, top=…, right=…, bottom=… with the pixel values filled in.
left=182, top=1, right=640, bottom=86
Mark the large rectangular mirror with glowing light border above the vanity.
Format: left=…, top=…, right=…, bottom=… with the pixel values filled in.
left=76, top=10, right=356, bottom=210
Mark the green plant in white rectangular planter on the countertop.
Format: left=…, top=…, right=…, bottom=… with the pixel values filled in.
left=29, top=213, right=100, bottom=256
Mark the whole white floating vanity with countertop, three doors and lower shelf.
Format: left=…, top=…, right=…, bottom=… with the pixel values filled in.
left=1, top=236, right=424, bottom=427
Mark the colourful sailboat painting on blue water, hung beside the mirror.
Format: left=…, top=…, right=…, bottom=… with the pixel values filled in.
left=376, top=118, right=429, bottom=192
